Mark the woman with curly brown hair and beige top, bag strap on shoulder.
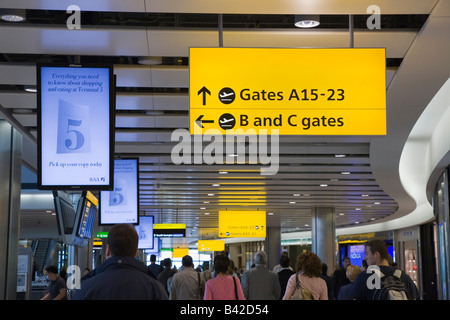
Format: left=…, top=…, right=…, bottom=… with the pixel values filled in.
left=283, top=251, right=328, bottom=300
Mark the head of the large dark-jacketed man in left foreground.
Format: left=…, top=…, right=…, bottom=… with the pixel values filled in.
left=106, top=224, right=139, bottom=259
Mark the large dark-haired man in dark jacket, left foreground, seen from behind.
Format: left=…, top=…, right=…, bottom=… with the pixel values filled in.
left=72, top=224, right=168, bottom=300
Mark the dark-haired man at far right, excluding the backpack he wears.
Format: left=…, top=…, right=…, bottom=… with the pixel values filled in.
left=350, top=239, right=419, bottom=300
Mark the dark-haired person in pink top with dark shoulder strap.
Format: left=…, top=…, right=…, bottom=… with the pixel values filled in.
left=203, top=254, right=245, bottom=300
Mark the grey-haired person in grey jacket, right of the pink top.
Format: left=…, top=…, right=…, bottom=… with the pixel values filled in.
left=241, top=251, right=281, bottom=300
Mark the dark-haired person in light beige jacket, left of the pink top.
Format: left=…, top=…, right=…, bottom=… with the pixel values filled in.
left=170, top=255, right=205, bottom=300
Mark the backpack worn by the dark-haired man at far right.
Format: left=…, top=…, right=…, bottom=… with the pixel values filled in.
left=372, top=270, right=409, bottom=300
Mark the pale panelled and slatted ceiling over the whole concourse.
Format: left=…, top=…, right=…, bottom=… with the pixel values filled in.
left=0, top=0, right=450, bottom=248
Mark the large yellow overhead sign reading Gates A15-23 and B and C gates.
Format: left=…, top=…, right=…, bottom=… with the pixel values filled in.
left=189, top=48, right=386, bottom=135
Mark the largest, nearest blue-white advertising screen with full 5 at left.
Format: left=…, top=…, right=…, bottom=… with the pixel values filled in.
left=37, top=64, right=115, bottom=190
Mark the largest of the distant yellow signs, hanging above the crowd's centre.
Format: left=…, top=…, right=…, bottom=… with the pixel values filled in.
left=219, top=211, right=266, bottom=238
